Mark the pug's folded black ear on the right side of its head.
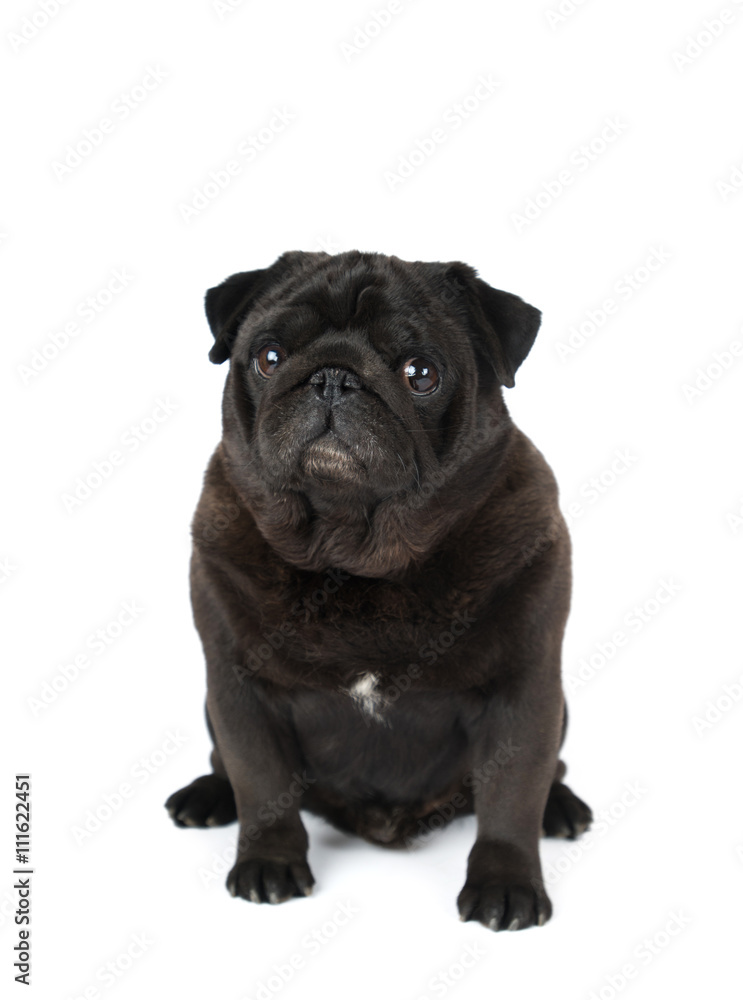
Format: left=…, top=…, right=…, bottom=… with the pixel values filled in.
left=446, top=263, right=542, bottom=389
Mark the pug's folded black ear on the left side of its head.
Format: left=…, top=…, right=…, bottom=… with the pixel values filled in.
left=204, top=250, right=314, bottom=365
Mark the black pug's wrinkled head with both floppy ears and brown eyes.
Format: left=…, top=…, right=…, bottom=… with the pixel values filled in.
left=206, top=251, right=540, bottom=576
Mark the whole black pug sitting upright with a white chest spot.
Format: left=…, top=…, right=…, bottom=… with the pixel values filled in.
left=166, top=252, right=591, bottom=930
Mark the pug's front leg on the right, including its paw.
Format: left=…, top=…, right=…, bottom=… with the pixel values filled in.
left=457, top=669, right=563, bottom=930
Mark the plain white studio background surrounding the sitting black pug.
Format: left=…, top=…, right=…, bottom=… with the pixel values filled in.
left=0, top=0, right=743, bottom=1000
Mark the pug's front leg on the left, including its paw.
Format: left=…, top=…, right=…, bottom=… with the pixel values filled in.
left=207, top=677, right=314, bottom=903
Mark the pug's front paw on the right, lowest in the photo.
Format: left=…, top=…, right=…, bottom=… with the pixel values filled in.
left=457, top=878, right=552, bottom=931
